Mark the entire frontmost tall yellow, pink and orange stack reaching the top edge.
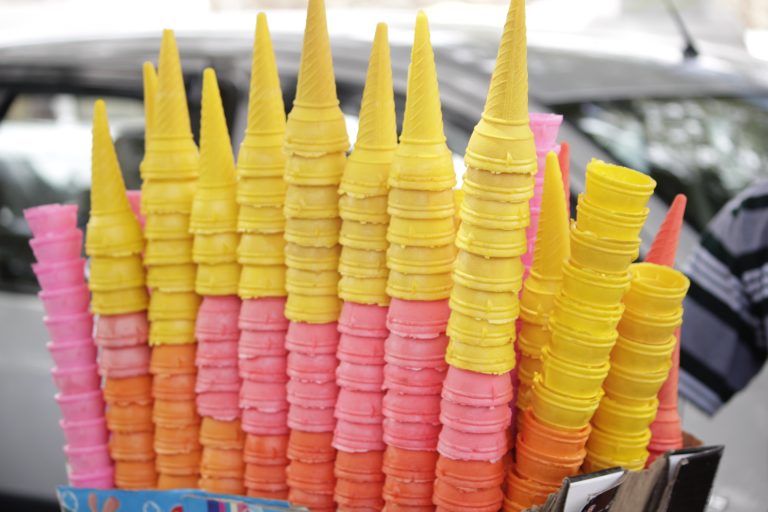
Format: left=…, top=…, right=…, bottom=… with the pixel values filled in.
left=434, top=0, right=536, bottom=511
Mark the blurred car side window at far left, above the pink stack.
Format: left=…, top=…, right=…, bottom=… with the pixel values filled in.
left=0, top=91, right=144, bottom=291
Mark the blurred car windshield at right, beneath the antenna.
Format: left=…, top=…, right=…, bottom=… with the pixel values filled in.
left=556, top=97, right=768, bottom=231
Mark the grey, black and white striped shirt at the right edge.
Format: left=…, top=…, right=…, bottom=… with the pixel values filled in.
left=680, top=182, right=768, bottom=414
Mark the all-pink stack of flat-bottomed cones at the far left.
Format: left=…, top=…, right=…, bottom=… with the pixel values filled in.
left=24, top=204, right=114, bottom=489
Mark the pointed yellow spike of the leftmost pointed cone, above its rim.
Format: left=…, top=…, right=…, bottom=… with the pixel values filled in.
left=91, top=100, right=131, bottom=215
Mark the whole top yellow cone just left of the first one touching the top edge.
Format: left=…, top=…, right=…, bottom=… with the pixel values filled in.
left=237, top=13, right=285, bottom=178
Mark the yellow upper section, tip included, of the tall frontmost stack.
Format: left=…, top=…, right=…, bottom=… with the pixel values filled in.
left=447, top=0, right=536, bottom=374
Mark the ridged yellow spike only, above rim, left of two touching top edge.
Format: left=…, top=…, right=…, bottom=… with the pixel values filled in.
left=296, top=0, right=339, bottom=107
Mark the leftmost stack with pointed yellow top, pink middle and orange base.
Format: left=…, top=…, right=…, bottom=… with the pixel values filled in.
left=86, top=100, right=157, bottom=489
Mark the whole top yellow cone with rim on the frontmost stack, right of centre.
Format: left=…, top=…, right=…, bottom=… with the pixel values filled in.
left=464, top=0, right=536, bottom=174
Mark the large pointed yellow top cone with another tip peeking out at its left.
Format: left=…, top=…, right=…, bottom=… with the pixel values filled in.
left=141, top=30, right=198, bottom=180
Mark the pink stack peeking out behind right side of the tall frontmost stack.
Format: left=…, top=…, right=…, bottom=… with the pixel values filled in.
left=522, top=112, right=563, bottom=277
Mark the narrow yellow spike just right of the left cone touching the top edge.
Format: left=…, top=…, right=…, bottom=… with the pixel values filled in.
left=355, top=23, right=397, bottom=150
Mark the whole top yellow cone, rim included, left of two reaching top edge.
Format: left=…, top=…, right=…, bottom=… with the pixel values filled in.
left=285, top=0, right=349, bottom=156
